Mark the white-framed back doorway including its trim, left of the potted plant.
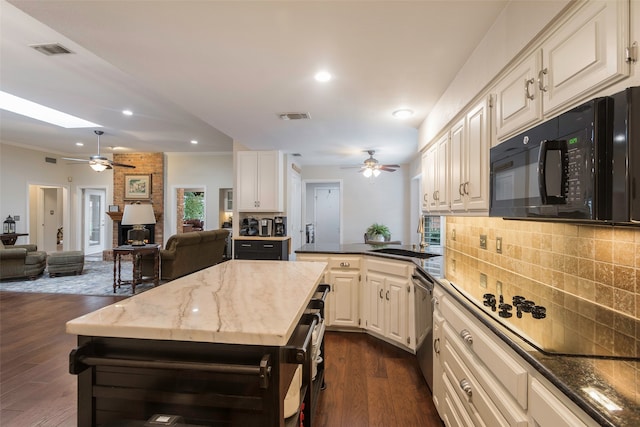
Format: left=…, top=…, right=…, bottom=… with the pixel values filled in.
left=305, top=181, right=342, bottom=244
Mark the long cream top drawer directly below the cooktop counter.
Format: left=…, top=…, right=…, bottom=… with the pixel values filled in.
left=440, top=298, right=528, bottom=409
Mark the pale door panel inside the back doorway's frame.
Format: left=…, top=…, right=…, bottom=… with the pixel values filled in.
left=314, top=187, right=340, bottom=243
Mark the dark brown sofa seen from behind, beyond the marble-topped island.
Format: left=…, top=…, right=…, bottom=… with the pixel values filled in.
left=142, top=230, right=229, bottom=280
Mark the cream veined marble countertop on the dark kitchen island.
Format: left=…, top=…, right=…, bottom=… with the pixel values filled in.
left=66, top=260, right=326, bottom=346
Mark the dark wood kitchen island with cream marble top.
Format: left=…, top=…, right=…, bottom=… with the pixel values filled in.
left=67, top=260, right=326, bottom=426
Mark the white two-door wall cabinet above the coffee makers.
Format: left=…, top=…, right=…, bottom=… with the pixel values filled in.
left=236, top=151, right=284, bottom=212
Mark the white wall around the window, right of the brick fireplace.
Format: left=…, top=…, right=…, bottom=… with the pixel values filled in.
left=164, top=153, right=235, bottom=243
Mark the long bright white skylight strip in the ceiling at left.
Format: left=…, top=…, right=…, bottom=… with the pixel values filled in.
left=0, top=91, right=102, bottom=129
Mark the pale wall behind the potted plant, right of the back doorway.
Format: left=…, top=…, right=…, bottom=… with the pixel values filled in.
left=302, top=165, right=410, bottom=244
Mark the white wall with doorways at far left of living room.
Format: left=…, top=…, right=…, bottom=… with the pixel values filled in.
left=0, top=143, right=113, bottom=250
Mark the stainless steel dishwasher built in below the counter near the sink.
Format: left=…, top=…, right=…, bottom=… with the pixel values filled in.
left=411, top=268, right=434, bottom=391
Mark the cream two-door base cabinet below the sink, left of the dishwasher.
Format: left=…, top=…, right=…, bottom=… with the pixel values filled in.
left=364, top=258, right=415, bottom=349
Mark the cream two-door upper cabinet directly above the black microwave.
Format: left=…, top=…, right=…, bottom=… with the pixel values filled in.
left=495, top=1, right=630, bottom=141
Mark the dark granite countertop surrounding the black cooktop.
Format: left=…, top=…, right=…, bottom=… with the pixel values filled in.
left=438, top=279, right=640, bottom=427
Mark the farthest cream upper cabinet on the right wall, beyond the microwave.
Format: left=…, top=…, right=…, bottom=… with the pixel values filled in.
left=422, top=133, right=449, bottom=212
